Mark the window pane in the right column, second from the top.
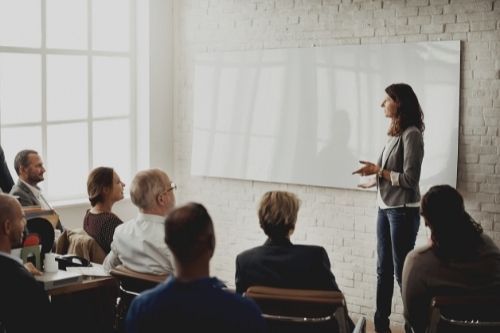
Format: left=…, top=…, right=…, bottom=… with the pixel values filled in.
left=92, top=57, right=130, bottom=117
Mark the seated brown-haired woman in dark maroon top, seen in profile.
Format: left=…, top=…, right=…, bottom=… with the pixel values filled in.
left=83, top=167, right=125, bottom=254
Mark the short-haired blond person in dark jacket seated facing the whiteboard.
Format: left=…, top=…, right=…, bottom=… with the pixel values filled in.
left=236, top=191, right=339, bottom=293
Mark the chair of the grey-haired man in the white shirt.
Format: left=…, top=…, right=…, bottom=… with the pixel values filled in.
left=110, top=265, right=168, bottom=332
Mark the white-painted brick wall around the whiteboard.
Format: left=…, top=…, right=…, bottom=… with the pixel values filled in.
left=174, top=0, right=500, bottom=322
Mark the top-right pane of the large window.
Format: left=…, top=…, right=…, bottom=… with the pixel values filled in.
left=92, top=0, right=130, bottom=51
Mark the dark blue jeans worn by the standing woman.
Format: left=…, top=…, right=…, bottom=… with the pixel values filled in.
left=374, top=207, right=420, bottom=332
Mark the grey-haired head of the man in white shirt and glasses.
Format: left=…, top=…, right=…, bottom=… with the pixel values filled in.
left=130, top=169, right=175, bottom=210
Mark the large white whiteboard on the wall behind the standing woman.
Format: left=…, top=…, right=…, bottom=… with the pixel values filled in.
left=191, top=41, right=460, bottom=189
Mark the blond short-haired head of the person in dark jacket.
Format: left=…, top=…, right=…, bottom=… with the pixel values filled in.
left=258, top=191, right=300, bottom=239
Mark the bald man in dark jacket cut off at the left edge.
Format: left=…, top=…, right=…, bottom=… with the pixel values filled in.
left=0, top=194, right=55, bottom=333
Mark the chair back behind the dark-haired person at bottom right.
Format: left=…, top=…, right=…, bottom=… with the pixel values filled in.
left=428, top=295, right=500, bottom=333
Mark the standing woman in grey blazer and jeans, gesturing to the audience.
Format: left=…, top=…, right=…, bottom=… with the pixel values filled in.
left=353, top=83, right=425, bottom=333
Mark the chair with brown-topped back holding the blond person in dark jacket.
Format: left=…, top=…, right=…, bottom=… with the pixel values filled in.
left=244, top=286, right=366, bottom=333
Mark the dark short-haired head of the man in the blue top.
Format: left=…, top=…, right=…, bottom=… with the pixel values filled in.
left=165, top=202, right=215, bottom=264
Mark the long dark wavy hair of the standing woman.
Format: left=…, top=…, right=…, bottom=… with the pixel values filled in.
left=385, top=83, right=425, bottom=136
